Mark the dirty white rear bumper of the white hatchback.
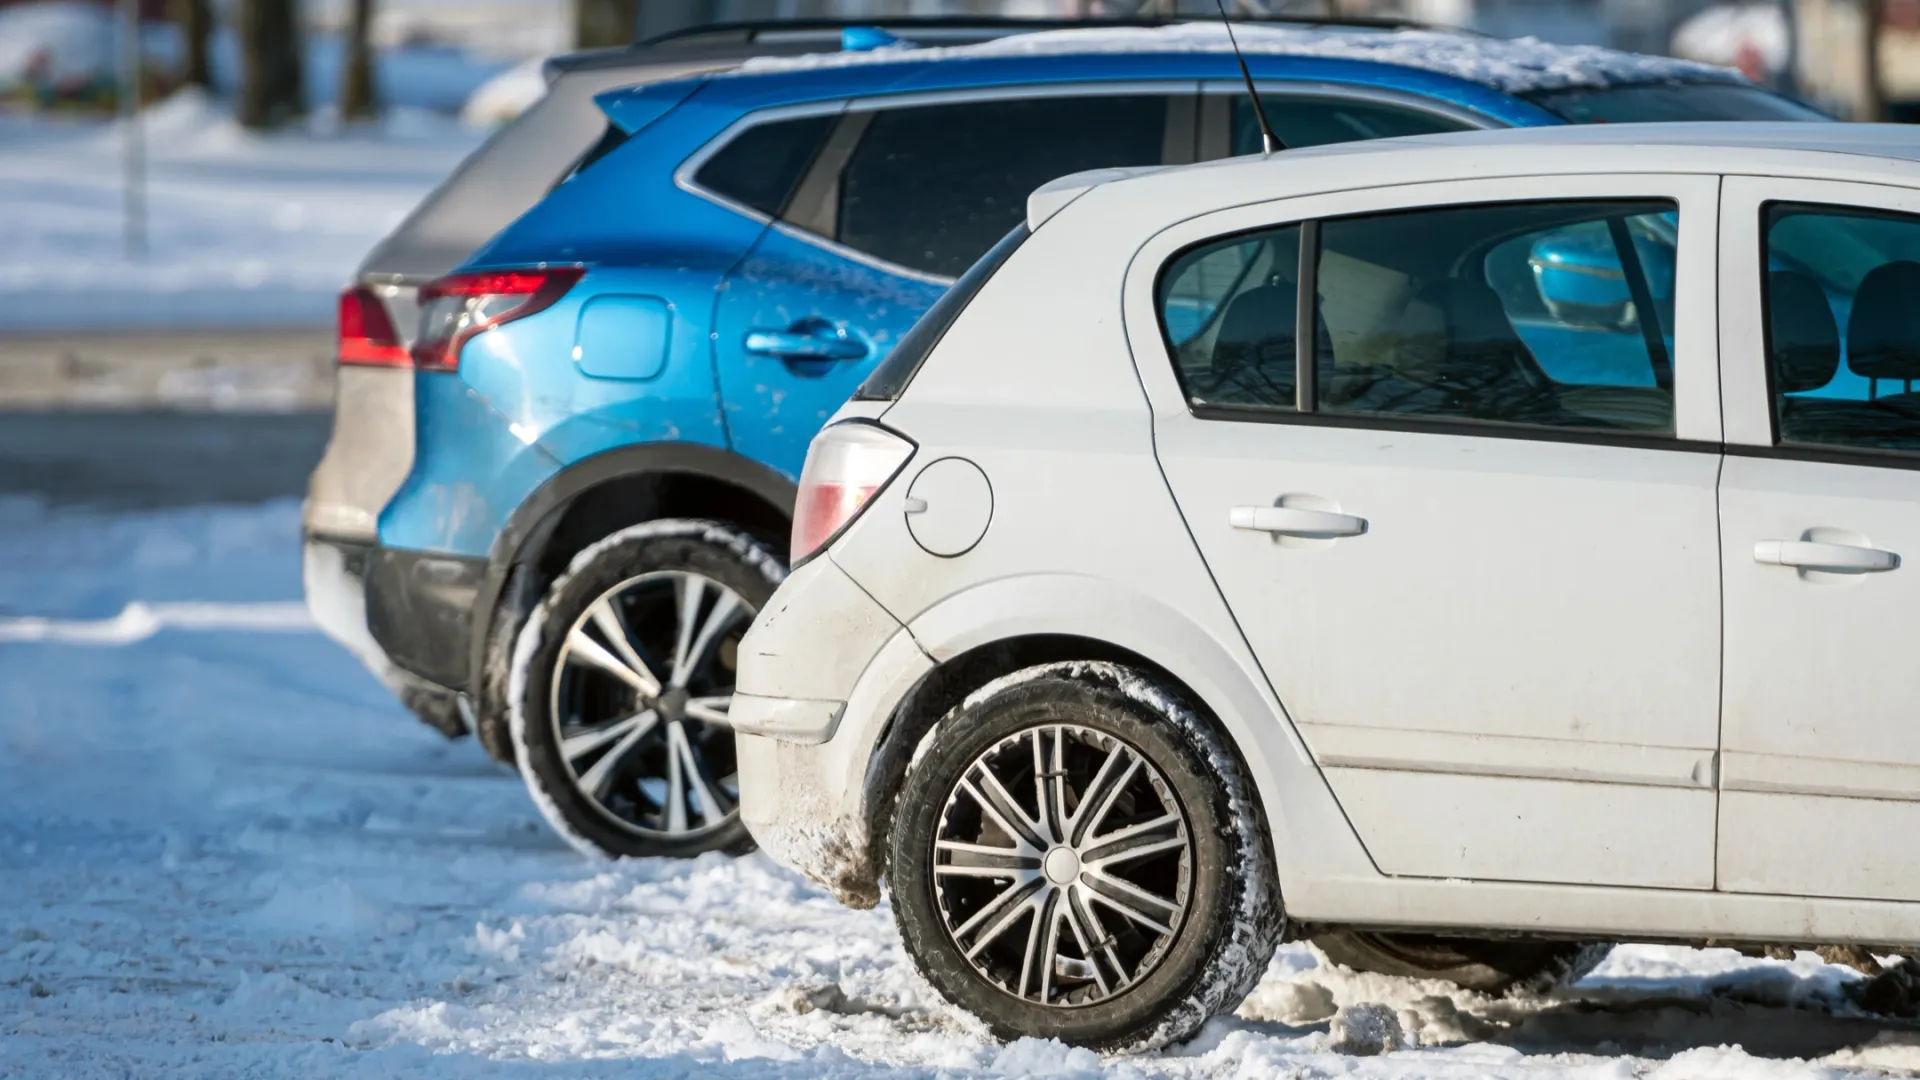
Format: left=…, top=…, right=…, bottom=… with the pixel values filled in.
left=728, top=557, right=933, bottom=907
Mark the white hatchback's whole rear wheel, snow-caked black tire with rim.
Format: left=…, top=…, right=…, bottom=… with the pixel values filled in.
left=889, top=661, right=1286, bottom=1049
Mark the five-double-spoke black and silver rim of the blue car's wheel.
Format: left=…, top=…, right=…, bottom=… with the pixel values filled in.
left=551, top=571, right=755, bottom=838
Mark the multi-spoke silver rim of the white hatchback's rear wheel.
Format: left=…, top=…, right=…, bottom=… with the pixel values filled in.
left=933, top=724, right=1194, bottom=1007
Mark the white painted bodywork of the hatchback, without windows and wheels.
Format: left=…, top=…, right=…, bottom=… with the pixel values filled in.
left=735, top=125, right=1920, bottom=945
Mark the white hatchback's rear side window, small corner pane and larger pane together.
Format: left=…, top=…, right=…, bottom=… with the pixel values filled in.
left=1160, top=200, right=1678, bottom=434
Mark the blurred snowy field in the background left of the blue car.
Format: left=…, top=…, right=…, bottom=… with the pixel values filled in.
left=0, top=92, right=486, bottom=334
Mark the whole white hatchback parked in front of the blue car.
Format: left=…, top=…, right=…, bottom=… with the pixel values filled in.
left=732, top=125, right=1920, bottom=1047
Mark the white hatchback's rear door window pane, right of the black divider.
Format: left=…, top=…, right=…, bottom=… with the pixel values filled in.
left=1315, top=202, right=1678, bottom=432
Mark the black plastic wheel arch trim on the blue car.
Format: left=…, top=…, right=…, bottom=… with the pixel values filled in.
left=461, top=442, right=799, bottom=686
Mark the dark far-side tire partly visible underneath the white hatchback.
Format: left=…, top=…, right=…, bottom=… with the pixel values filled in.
left=1313, top=930, right=1609, bottom=994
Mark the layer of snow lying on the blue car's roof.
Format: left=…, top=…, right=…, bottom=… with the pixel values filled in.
left=737, top=23, right=1745, bottom=94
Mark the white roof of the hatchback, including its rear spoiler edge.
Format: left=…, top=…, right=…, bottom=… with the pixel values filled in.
left=1027, top=121, right=1920, bottom=229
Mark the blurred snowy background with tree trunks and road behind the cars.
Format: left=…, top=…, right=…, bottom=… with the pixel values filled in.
left=0, top=0, right=1889, bottom=502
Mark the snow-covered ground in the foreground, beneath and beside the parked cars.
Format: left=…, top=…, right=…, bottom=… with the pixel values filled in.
left=0, top=498, right=1920, bottom=1080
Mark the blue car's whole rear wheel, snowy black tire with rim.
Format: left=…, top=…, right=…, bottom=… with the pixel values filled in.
left=507, top=521, right=785, bottom=857
